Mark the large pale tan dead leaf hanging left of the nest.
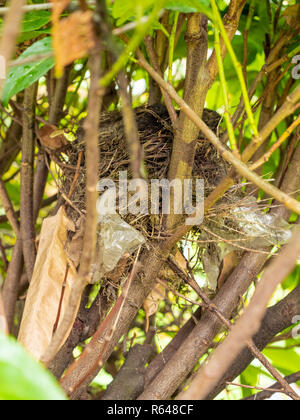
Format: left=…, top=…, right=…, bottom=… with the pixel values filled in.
left=19, top=207, right=77, bottom=359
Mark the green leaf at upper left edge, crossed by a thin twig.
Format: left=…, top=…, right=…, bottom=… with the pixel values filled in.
left=2, top=37, right=54, bottom=106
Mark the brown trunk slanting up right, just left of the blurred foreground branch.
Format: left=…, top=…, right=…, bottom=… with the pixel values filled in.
left=140, top=142, right=300, bottom=400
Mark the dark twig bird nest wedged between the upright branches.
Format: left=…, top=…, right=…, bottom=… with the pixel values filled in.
left=60, top=101, right=228, bottom=233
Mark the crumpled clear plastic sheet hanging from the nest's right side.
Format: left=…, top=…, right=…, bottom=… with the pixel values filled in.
left=201, top=197, right=292, bottom=290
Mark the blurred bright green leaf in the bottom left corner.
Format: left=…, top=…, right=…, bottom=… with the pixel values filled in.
left=0, top=334, right=66, bottom=401
